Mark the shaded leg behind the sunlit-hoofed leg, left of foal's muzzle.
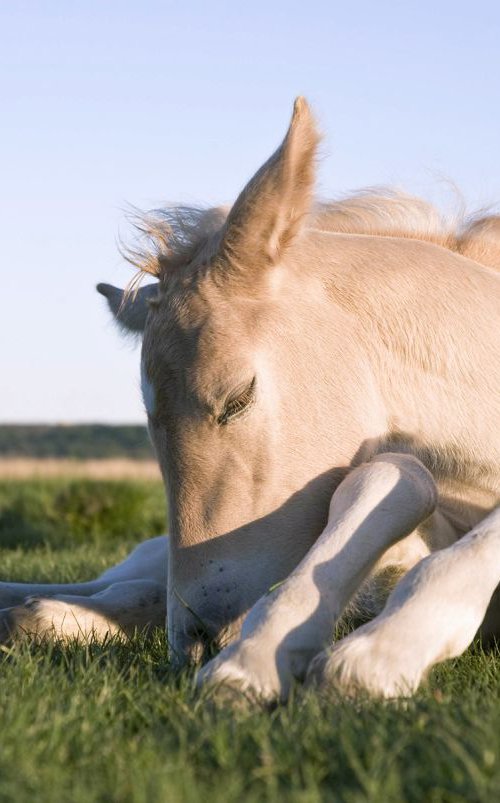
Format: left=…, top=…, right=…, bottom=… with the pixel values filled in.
left=0, top=535, right=168, bottom=609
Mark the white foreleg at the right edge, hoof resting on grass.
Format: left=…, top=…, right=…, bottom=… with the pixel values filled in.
left=308, top=508, right=500, bottom=697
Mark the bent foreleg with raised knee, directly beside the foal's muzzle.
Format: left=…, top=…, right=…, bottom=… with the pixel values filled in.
left=198, top=454, right=436, bottom=700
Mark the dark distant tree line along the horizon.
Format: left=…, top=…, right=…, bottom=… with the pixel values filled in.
left=0, top=424, right=153, bottom=460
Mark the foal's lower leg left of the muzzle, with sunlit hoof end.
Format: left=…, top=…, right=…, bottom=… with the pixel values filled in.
left=0, top=580, right=166, bottom=642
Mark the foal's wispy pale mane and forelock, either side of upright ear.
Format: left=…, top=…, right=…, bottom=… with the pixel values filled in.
left=122, top=188, right=500, bottom=291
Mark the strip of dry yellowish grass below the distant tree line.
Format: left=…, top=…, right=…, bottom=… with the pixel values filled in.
left=0, top=457, right=160, bottom=480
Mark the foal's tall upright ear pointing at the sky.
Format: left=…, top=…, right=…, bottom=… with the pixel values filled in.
left=220, top=98, right=319, bottom=269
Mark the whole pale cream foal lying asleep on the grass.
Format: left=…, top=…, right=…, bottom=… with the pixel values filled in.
left=0, top=99, right=500, bottom=700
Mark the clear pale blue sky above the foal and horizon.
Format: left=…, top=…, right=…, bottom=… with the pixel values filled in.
left=0, top=0, right=500, bottom=423
